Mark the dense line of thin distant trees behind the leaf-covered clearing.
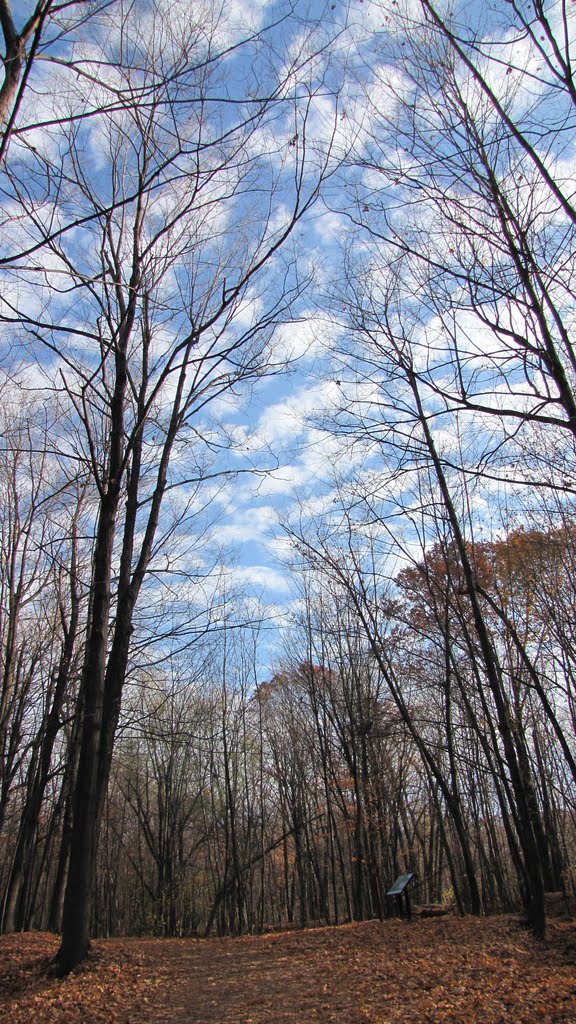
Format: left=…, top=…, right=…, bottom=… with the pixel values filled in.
left=0, top=495, right=576, bottom=935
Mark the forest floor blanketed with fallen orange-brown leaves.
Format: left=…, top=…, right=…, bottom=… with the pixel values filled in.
left=0, top=915, right=576, bottom=1024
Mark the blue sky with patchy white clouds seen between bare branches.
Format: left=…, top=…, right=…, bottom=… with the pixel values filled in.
left=0, top=0, right=576, bottom=676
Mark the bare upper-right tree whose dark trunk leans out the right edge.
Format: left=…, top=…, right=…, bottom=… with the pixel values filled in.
left=340, top=0, right=576, bottom=492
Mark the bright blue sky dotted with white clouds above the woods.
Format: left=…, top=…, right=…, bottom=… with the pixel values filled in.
left=0, top=0, right=576, bottom=673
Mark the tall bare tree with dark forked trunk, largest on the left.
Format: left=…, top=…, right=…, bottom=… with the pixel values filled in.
left=2, top=2, right=340, bottom=971
